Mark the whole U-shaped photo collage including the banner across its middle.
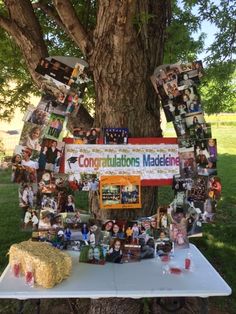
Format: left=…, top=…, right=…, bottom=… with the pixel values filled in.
left=12, top=58, right=221, bottom=264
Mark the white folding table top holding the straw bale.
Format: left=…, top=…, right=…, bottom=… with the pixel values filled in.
left=0, top=244, right=231, bottom=312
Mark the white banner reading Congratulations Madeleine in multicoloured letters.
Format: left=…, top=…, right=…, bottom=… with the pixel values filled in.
left=65, top=144, right=179, bottom=180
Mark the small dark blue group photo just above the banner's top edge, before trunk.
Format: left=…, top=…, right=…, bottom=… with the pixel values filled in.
left=103, top=128, right=129, bottom=144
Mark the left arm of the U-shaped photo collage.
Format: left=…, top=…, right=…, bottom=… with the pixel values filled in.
left=11, top=59, right=94, bottom=237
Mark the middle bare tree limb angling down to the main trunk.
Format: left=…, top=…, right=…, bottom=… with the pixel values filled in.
left=53, top=0, right=92, bottom=56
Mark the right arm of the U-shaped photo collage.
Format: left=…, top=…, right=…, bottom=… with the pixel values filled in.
left=151, top=61, right=222, bottom=228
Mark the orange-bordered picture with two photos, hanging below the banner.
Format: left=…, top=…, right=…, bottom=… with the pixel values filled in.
left=100, top=176, right=141, bottom=208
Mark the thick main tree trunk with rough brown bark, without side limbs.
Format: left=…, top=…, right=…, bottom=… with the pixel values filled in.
left=88, top=0, right=169, bottom=219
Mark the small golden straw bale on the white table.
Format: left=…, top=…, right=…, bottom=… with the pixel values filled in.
left=9, top=241, right=72, bottom=288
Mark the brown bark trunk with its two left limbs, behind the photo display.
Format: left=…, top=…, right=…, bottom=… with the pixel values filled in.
left=0, top=0, right=175, bottom=221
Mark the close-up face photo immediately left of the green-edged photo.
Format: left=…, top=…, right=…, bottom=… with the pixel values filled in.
left=19, top=122, right=44, bottom=151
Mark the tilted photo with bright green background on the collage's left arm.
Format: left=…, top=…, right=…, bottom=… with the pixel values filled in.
left=44, top=113, right=66, bottom=140
